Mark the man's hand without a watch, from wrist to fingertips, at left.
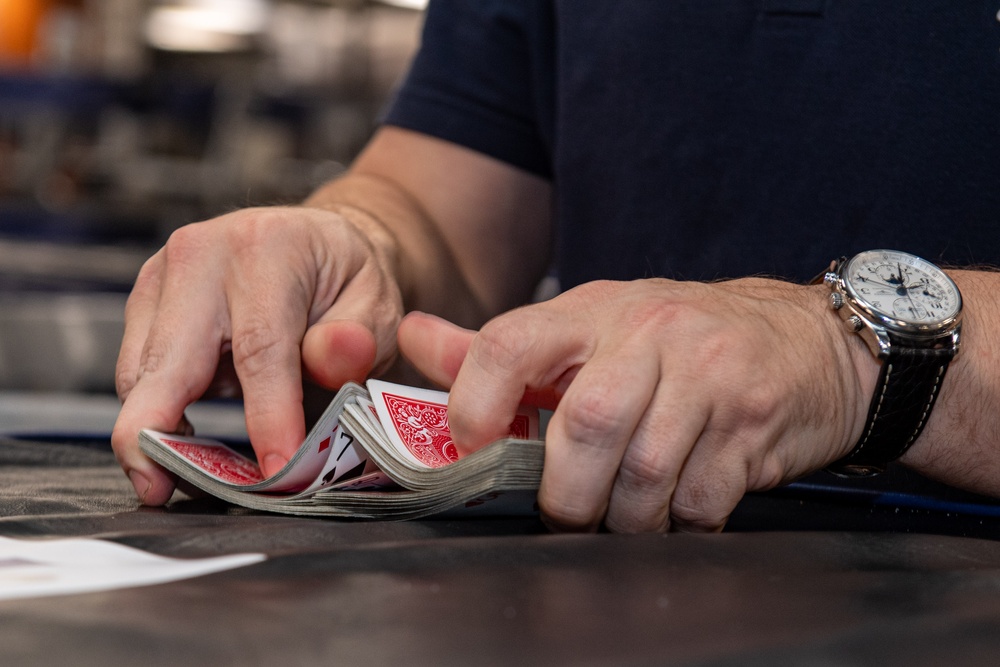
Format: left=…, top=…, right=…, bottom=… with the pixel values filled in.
left=111, top=207, right=403, bottom=505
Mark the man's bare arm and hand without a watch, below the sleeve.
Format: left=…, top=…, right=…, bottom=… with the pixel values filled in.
left=112, top=127, right=551, bottom=505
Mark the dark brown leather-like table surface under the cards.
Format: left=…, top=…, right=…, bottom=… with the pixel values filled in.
left=0, top=396, right=1000, bottom=665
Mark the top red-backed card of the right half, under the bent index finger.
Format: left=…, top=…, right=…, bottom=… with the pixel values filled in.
left=368, top=380, right=538, bottom=468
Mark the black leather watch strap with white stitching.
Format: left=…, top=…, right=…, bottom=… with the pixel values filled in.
left=829, top=347, right=955, bottom=476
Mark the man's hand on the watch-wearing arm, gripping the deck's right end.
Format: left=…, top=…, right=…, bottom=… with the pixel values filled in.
left=399, top=278, right=877, bottom=532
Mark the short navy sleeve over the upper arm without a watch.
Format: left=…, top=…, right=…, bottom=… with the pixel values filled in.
left=383, top=0, right=554, bottom=178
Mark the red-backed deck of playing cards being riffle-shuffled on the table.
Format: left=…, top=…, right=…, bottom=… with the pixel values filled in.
left=139, top=380, right=544, bottom=519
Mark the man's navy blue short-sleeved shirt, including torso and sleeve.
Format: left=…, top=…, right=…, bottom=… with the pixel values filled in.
left=386, top=0, right=1000, bottom=287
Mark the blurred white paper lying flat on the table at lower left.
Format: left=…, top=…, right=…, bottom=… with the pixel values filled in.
left=0, top=537, right=266, bottom=600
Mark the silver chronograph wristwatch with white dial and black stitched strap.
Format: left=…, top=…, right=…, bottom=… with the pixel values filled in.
left=823, top=250, right=962, bottom=477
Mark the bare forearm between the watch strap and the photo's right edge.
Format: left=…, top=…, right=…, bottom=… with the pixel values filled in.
left=902, top=271, right=1000, bottom=496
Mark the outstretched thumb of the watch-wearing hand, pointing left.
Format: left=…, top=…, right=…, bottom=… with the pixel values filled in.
left=397, top=312, right=476, bottom=389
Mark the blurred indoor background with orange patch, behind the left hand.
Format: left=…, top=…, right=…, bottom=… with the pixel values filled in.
left=0, top=0, right=424, bottom=412
